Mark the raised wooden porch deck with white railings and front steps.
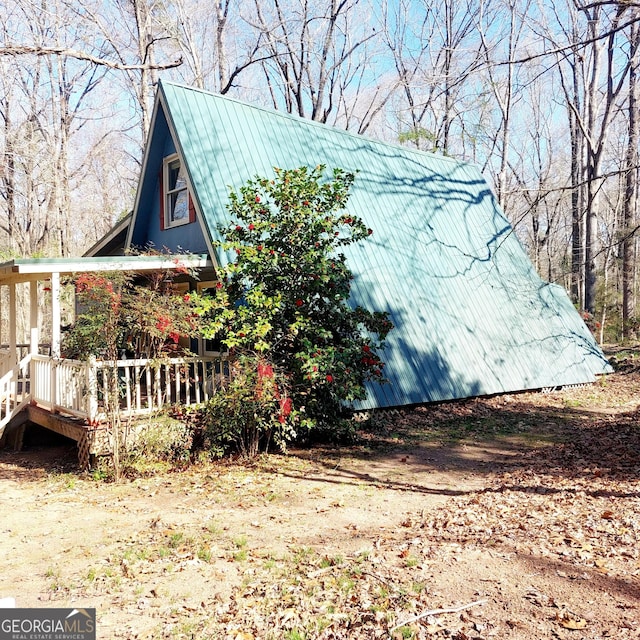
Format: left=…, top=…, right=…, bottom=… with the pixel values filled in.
left=0, top=354, right=229, bottom=469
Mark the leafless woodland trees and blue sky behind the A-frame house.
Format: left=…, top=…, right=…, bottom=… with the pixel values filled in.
left=0, top=0, right=640, bottom=336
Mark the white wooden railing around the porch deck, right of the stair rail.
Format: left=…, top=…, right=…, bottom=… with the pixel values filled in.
left=31, top=355, right=229, bottom=424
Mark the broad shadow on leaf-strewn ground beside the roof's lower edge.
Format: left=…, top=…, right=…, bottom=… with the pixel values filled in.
left=289, top=394, right=640, bottom=497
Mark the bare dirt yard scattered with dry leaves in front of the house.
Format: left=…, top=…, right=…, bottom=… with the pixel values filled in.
left=0, top=361, right=640, bottom=640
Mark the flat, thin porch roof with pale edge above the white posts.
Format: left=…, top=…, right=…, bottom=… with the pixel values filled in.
left=0, top=254, right=213, bottom=284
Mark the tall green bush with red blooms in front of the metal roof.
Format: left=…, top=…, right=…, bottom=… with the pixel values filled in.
left=196, top=165, right=393, bottom=450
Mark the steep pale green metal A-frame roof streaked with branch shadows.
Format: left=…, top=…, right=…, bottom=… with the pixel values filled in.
left=154, top=83, right=609, bottom=407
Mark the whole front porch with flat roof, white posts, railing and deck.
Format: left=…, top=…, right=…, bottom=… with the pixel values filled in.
left=0, top=256, right=229, bottom=468
